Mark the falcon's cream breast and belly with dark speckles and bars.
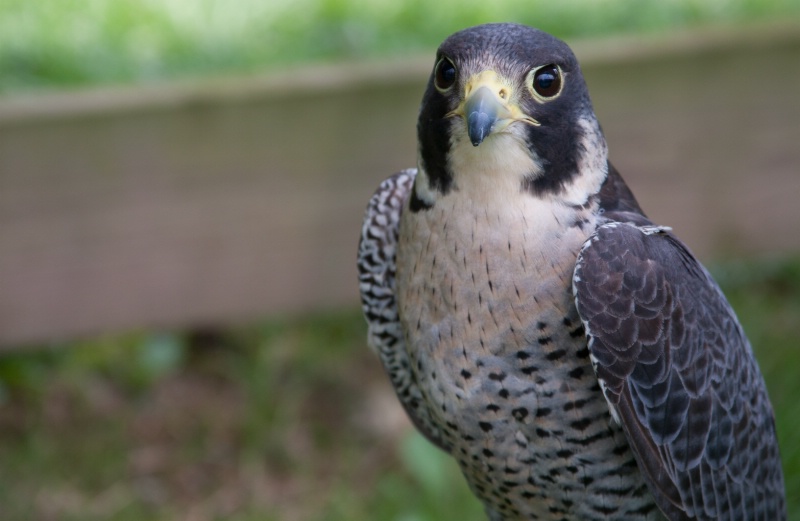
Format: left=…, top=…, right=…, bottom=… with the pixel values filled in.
left=396, top=197, right=659, bottom=520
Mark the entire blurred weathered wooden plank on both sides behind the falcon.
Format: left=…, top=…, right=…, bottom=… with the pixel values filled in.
left=0, top=26, right=800, bottom=348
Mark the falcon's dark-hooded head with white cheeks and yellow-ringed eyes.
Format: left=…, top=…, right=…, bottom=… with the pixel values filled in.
left=412, top=24, right=608, bottom=208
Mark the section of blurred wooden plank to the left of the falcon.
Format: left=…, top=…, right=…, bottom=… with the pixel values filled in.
left=0, top=85, right=418, bottom=345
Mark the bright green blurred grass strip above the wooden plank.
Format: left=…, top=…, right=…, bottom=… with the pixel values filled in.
left=0, top=0, right=800, bottom=93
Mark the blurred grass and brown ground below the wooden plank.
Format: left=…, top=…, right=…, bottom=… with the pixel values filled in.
left=0, top=257, right=800, bottom=521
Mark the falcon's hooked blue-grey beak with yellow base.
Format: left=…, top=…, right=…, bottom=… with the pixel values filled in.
left=448, top=70, right=539, bottom=146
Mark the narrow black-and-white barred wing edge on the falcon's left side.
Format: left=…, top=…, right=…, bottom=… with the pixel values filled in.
left=358, top=169, right=449, bottom=451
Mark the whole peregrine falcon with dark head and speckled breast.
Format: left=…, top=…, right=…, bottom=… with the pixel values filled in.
left=358, top=24, right=786, bottom=521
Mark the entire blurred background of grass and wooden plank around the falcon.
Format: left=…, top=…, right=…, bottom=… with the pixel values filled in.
left=0, top=0, right=800, bottom=521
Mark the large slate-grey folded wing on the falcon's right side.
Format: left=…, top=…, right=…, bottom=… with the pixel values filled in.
left=573, top=220, right=786, bottom=520
